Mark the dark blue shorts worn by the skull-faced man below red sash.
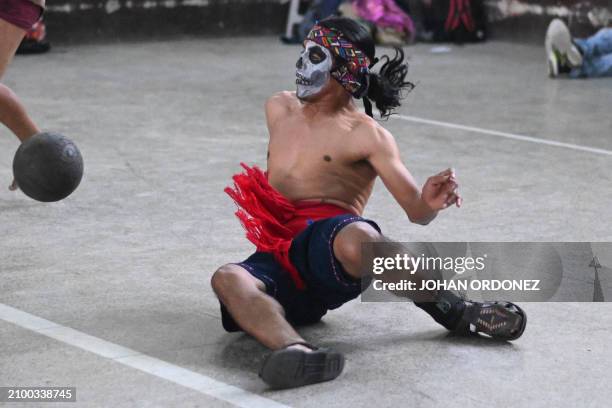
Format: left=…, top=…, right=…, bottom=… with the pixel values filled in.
left=221, top=214, right=380, bottom=332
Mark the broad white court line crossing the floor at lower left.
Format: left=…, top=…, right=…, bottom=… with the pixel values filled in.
left=0, top=303, right=288, bottom=408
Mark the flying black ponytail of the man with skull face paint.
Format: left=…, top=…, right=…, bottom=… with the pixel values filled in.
left=362, top=47, right=414, bottom=118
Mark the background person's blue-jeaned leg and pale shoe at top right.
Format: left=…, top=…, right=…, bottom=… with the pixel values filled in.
left=545, top=19, right=612, bottom=78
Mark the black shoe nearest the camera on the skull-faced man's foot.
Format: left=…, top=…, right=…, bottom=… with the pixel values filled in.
left=259, top=343, right=344, bottom=389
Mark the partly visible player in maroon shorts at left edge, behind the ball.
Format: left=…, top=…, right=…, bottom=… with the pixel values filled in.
left=0, top=0, right=45, bottom=190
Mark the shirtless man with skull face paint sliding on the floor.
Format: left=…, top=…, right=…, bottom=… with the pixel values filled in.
left=212, top=18, right=526, bottom=388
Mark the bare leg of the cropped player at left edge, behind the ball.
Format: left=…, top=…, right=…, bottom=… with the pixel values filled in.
left=0, top=19, right=40, bottom=190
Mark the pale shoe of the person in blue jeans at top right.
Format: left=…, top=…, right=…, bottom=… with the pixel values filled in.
left=544, top=18, right=582, bottom=78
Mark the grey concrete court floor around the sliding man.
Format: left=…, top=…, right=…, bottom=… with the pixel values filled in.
left=0, top=38, right=612, bottom=407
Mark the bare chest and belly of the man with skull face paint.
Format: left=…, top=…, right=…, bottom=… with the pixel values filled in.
left=268, top=92, right=376, bottom=214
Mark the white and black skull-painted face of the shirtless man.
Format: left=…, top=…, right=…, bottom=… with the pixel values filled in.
left=295, top=40, right=334, bottom=99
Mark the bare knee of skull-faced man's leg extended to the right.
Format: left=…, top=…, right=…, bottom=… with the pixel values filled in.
left=333, top=221, right=382, bottom=272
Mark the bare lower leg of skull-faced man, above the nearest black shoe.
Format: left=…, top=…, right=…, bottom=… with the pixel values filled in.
left=211, top=264, right=310, bottom=351
